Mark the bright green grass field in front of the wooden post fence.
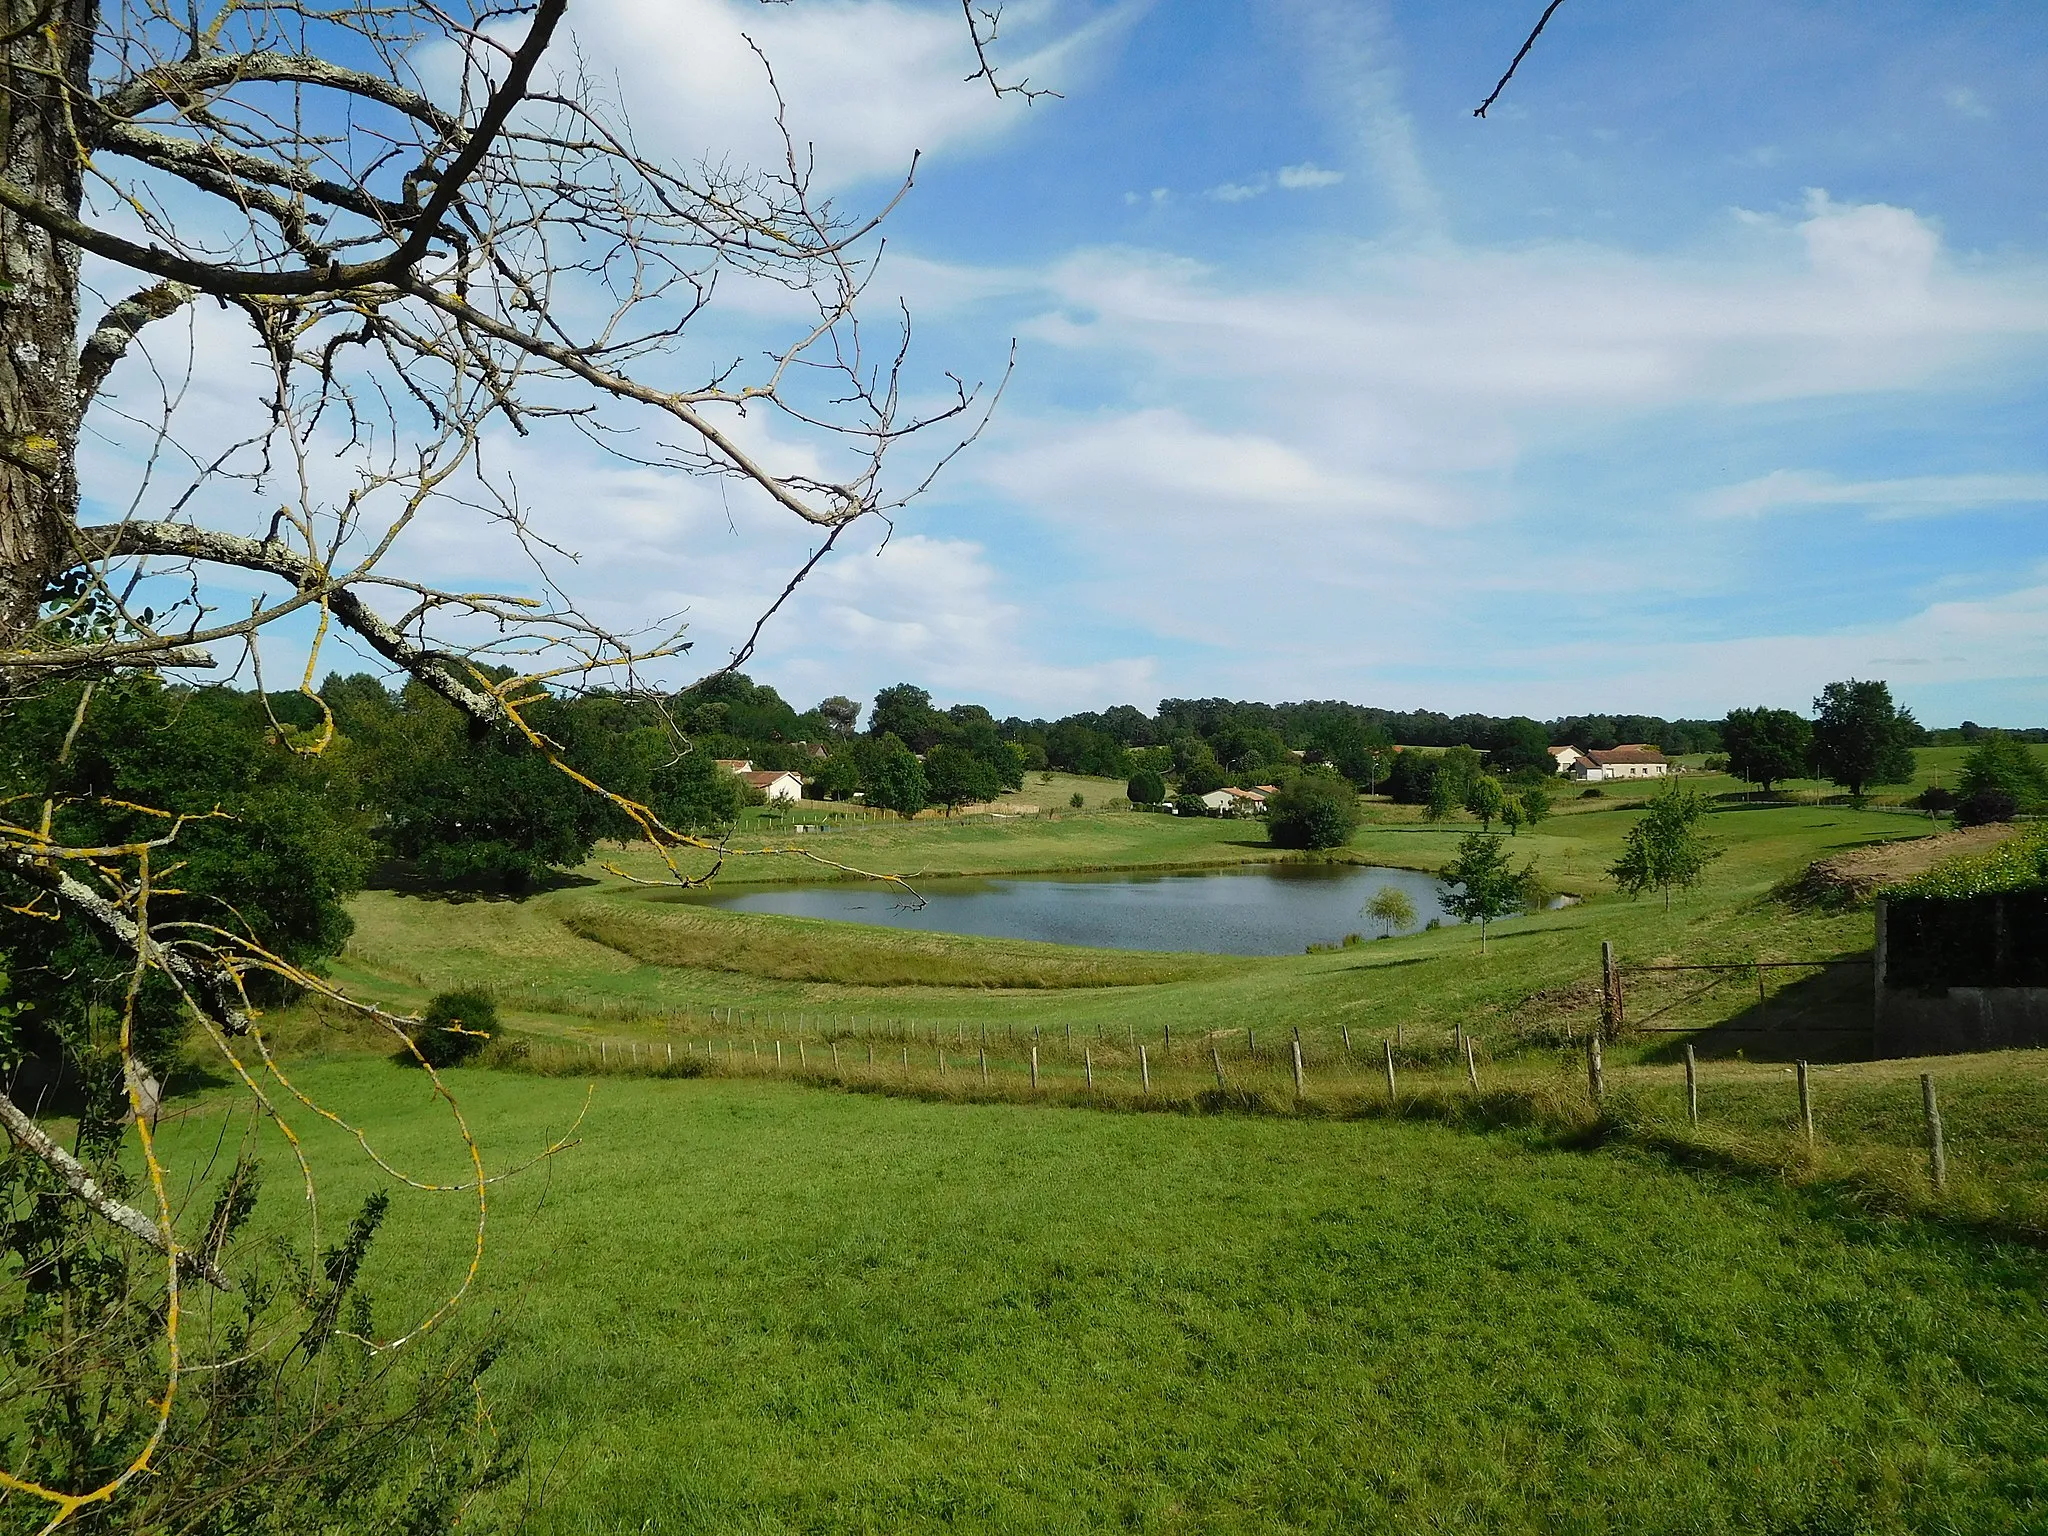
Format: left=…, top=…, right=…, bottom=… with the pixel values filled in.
left=144, top=1057, right=2048, bottom=1536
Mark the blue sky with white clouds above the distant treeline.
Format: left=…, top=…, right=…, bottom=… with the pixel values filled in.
left=79, top=0, right=2048, bottom=725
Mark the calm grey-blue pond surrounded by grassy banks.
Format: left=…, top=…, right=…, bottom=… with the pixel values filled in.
left=662, top=864, right=1507, bottom=954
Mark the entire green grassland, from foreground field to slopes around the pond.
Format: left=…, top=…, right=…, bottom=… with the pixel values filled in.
left=168, top=761, right=2048, bottom=1532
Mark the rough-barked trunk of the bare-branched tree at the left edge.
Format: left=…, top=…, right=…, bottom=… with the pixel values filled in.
left=0, top=0, right=98, bottom=647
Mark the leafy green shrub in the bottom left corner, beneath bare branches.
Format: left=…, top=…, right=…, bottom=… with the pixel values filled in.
left=0, top=1116, right=518, bottom=1536
